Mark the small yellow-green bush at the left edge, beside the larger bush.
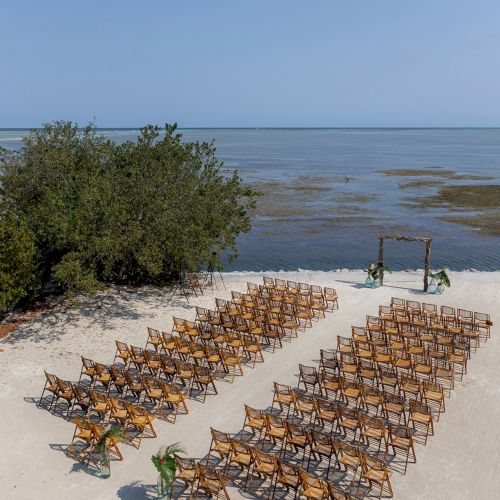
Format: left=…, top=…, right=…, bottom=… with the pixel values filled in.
left=0, top=213, right=40, bottom=311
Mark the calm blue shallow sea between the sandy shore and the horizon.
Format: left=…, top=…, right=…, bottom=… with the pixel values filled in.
left=0, top=129, right=500, bottom=271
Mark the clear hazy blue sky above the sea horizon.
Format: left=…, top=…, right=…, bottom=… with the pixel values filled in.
left=0, top=0, right=500, bottom=128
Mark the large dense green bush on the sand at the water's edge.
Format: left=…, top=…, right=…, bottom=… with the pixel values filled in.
left=0, top=122, right=258, bottom=300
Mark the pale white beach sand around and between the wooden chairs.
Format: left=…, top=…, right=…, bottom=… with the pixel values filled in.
left=0, top=271, right=500, bottom=500
